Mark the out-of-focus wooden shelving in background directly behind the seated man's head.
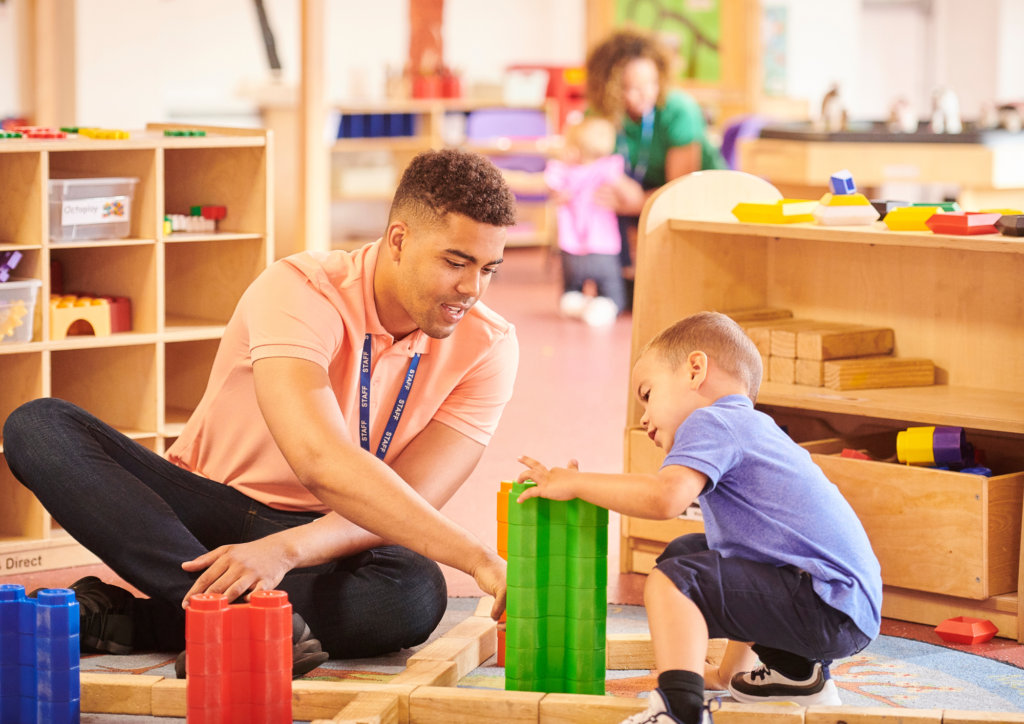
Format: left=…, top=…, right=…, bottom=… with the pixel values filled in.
left=331, top=99, right=558, bottom=250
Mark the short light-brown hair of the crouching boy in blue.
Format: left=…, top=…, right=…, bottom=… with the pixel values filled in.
left=637, top=311, right=762, bottom=402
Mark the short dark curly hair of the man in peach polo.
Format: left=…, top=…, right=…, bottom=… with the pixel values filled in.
left=388, top=148, right=516, bottom=226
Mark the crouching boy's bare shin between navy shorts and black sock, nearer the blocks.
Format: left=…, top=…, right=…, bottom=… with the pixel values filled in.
left=643, top=568, right=704, bottom=676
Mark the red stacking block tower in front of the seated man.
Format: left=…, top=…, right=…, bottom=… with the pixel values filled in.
left=185, top=591, right=292, bottom=724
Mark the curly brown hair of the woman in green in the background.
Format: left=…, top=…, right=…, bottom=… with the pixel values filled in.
left=587, top=29, right=671, bottom=126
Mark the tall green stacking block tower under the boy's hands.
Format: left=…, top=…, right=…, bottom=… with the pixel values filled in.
left=505, top=481, right=608, bottom=694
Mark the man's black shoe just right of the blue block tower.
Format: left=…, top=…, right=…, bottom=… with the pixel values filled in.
left=70, top=576, right=135, bottom=655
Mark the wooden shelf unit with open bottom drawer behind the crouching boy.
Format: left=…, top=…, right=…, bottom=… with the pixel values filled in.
left=621, top=184, right=1024, bottom=640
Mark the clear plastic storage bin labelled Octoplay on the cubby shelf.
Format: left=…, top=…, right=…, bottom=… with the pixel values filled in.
left=50, top=178, right=138, bottom=243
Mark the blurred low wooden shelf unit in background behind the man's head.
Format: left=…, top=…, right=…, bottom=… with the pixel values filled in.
left=331, top=99, right=558, bottom=251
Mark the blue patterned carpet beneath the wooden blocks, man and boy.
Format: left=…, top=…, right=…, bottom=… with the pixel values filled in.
left=75, top=598, right=1024, bottom=724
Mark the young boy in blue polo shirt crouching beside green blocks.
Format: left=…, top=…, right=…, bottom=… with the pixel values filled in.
left=519, top=312, right=882, bottom=724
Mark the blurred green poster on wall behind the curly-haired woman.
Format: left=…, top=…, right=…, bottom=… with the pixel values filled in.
left=615, top=0, right=722, bottom=84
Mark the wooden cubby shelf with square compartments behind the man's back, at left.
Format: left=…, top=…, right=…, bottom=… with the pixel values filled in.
left=0, top=125, right=273, bottom=574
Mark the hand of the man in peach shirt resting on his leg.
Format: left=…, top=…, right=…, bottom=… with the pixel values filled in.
left=181, top=536, right=292, bottom=608
